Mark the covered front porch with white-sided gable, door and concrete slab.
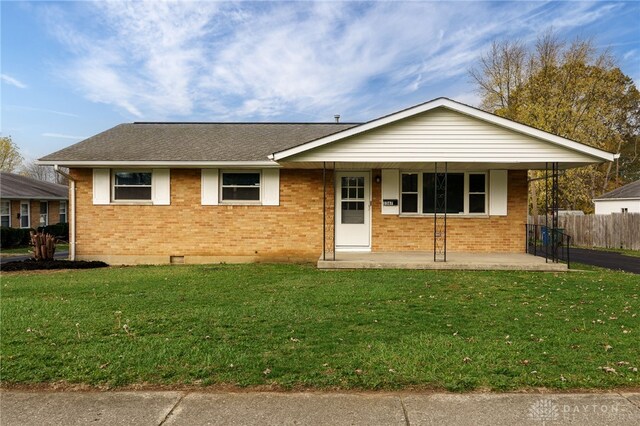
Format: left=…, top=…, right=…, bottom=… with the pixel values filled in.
left=270, top=99, right=614, bottom=271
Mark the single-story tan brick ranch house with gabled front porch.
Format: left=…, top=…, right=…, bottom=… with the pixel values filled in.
left=40, top=98, right=614, bottom=264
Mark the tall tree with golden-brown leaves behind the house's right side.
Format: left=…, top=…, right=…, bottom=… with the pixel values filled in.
left=471, top=32, right=640, bottom=212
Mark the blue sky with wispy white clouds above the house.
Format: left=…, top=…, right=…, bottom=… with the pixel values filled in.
left=0, top=1, right=640, bottom=159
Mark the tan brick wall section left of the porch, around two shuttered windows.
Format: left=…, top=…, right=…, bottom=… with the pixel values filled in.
left=71, top=169, right=322, bottom=263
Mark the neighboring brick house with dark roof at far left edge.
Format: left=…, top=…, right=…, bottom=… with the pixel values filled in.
left=0, top=172, right=69, bottom=229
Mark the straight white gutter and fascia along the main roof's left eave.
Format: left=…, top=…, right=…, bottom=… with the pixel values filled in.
left=36, top=160, right=280, bottom=168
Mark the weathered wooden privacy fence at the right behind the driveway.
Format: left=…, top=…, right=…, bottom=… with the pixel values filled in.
left=529, top=213, right=640, bottom=250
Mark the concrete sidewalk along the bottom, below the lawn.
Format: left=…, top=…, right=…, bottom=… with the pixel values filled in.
left=0, top=390, right=640, bottom=426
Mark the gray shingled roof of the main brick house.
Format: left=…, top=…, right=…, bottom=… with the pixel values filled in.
left=40, top=123, right=358, bottom=162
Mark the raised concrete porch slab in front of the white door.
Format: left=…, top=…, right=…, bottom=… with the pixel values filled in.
left=318, top=252, right=568, bottom=272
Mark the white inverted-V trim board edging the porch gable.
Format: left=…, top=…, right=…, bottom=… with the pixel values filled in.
left=269, top=98, right=615, bottom=161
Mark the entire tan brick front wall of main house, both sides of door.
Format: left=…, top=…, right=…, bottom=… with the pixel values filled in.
left=71, top=169, right=527, bottom=263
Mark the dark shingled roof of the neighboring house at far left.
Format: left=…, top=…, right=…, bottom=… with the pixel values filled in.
left=0, top=172, right=69, bottom=200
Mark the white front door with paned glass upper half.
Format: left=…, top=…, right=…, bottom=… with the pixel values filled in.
left=336, top=172, right=371, bottom=250
